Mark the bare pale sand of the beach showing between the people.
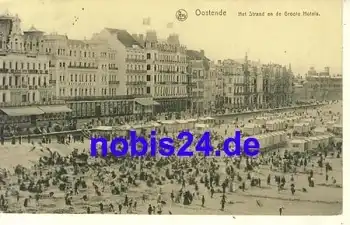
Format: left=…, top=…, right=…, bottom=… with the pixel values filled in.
left=0, top=101, right=342, bottom=215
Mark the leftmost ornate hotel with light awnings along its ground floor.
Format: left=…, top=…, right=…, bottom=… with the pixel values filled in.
left=0, top=13, right=67, bottom=125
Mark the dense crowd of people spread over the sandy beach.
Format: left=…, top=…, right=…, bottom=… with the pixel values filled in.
left=0, top=101, right=342, bottom=215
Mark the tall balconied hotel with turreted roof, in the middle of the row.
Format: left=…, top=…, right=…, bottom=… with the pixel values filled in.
left=133, top=30, right=188, bottom=113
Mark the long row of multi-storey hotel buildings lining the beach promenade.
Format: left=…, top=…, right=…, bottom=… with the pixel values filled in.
left=0, top=13, right=342, bottom=125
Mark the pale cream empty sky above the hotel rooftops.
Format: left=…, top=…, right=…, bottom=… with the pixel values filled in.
left=0, top=0, right=342, bottom=75
